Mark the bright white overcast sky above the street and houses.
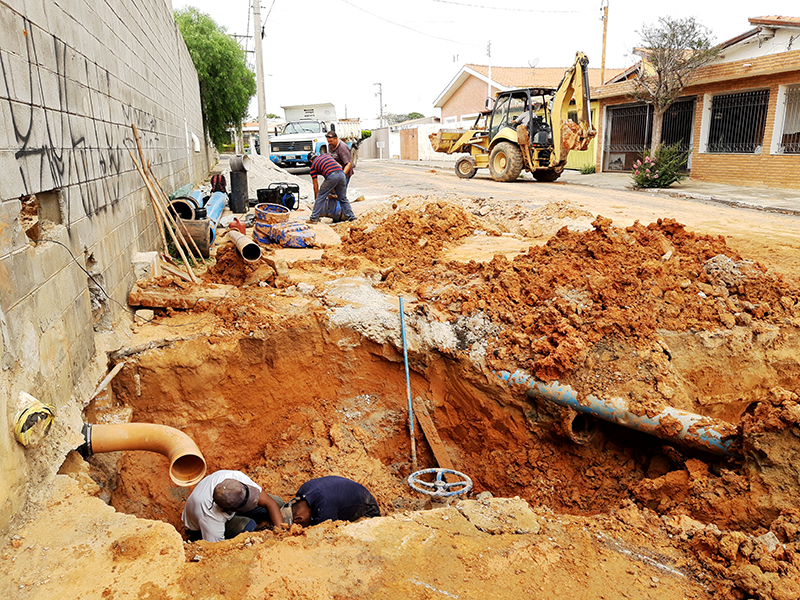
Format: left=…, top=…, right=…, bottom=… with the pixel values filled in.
left=172, top=0, right=800, bottom=126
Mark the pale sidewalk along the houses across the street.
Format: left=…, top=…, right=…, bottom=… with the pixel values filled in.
left=380, top=159, right=800, bottom=216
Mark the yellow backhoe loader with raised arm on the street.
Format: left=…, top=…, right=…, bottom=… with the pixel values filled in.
left=430, top=52, right=597, bottom=181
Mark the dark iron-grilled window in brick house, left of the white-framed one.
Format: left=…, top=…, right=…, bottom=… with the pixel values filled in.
left=708, top=90, right=769, bottom=154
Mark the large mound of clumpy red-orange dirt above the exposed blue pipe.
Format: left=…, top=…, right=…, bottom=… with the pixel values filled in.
left=454, top=218, right=800, bottom=381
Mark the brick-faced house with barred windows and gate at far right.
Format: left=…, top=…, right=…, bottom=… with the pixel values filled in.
left=592, top=16, right=800, bottom=189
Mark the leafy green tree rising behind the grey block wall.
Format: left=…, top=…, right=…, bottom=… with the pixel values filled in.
left=175, top=7, right=256, bottom=147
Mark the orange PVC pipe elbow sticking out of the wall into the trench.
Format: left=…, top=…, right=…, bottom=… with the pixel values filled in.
left=84, top=423, right=206, bottom=487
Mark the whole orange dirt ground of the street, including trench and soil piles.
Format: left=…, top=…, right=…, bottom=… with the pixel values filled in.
left=6, top=161, right=800, bottom=600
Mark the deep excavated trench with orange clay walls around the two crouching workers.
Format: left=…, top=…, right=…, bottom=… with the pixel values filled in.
left=88, top=310, right=792, bottom=532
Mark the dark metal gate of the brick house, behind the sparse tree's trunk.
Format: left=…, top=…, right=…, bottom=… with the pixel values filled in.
left=603, top=98, right=695, bottom=171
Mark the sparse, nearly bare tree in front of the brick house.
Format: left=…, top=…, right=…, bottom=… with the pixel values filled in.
left=631, top=17, right=721, bottom=152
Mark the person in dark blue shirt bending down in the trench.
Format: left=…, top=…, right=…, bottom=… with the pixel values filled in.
left=292, top=475, right=381, bottom=527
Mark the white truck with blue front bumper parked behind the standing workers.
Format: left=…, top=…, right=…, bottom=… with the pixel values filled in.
left=269, top=104, right=361, bottom=167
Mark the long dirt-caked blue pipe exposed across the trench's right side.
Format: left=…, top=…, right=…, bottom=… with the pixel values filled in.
left=495, top=370, right=739, bottom=456
